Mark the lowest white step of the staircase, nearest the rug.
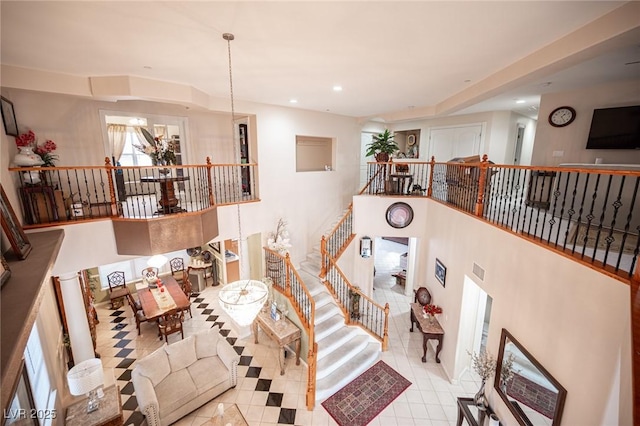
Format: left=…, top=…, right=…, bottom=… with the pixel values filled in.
left=316, top=343, right=380, bottom=401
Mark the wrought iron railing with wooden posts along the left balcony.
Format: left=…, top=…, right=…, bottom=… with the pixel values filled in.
left=9, top=159, right=258, bottom=228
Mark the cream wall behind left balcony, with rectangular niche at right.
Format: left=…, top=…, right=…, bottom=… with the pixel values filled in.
left=0, top=88, right=360, bottom=274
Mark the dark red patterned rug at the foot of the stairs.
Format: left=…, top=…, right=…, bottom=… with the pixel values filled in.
left=322, top=361, right=411, bottom=426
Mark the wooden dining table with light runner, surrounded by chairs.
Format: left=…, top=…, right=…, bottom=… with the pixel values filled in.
left=138, top=275, right=191, bottom=321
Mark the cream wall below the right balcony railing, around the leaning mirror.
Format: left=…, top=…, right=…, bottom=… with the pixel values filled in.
left=354, top=196, right=631, bottom=425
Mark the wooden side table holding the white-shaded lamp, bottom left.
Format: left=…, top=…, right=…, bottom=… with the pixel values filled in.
left=65, top=385, right=124, bottom=426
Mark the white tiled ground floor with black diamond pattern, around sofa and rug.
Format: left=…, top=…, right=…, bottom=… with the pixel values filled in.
left=97, top=243, right=479, bottom=426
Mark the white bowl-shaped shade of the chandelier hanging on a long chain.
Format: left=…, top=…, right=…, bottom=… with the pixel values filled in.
left=218, top=280, right=269, bottom=326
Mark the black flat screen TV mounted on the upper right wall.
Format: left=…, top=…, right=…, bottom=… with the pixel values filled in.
left=587, top=105, right=640, bottom=149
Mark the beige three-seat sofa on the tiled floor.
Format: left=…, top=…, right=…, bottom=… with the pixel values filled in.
left=131, top=327, right=240, bottom=426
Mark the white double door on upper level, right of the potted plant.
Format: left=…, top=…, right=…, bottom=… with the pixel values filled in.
left=428, top=124, right=483, bottom=163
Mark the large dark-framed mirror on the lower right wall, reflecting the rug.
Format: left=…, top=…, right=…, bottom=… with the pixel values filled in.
left=494, top=328, right=567, bottom=426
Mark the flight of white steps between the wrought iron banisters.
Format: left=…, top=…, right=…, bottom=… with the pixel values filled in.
left=298, top=248, right=382, bottom=401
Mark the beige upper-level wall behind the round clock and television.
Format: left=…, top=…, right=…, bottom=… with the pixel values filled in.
left=531, top=79, right=640, bottom=166
